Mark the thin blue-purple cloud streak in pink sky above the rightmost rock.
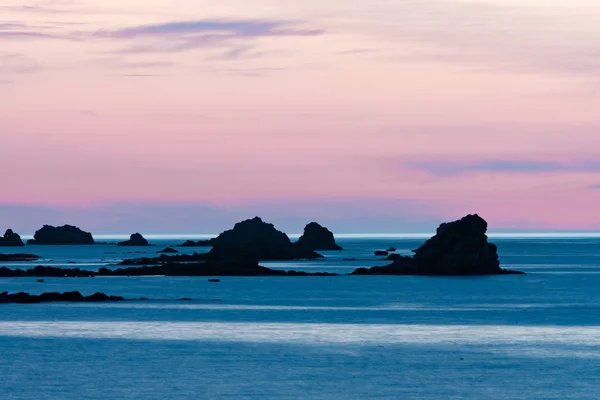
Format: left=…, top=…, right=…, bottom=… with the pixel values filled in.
left=404, top=160, right=600, bottom=176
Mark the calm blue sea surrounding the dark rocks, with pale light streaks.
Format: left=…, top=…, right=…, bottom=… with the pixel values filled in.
left=0, top=238, right=600, bottom=400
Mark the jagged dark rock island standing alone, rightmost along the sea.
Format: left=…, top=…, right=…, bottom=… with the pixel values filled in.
left=352, top=214, right=524, bottom=276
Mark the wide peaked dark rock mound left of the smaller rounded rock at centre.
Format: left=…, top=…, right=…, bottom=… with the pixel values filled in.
left=176, top=217, right=323, bottom=261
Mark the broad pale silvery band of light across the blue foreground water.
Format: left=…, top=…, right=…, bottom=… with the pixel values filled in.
left=0, top=321, right=600, bottom=346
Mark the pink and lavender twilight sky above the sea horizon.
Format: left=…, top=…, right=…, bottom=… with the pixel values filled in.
left=0, top=0, right=600, bottom=233
